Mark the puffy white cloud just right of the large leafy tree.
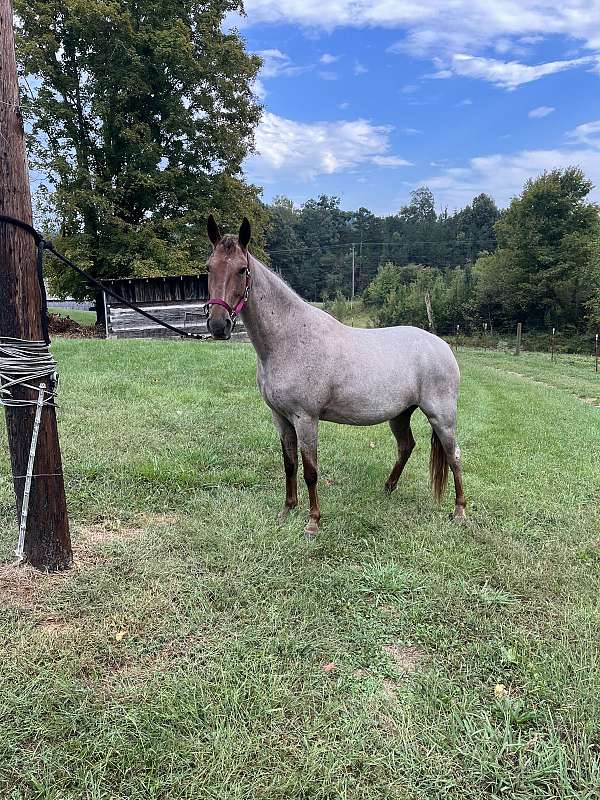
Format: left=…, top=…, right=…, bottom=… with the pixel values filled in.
left=246, top=112, right=409, bottom=183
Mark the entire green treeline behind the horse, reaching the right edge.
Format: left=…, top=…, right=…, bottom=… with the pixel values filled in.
left=267, top=167, right=600, bottom=333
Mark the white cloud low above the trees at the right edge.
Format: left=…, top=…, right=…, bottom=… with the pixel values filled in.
left=422, top=147, right=600, bottom=209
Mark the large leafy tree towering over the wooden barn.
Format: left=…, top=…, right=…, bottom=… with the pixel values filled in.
left=15, top=0, right=265, bottom=318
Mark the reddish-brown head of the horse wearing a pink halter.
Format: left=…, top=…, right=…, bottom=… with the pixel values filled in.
left=206, top=214, right=251, bottom=339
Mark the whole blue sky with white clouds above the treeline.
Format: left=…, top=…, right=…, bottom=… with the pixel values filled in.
left=228, top=0, right=600, bottom=213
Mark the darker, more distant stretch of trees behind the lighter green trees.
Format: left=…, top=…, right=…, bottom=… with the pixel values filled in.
left=266, top=187, right=500, bottom=300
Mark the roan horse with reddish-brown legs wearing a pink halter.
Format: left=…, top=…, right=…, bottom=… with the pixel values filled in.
left=207, top=215, right=466, bottom=536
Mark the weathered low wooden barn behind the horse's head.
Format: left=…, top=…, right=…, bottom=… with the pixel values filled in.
left=104, top=274, right=244, bottom=339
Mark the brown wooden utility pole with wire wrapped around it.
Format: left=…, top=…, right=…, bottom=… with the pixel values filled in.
left=0, top=0, right=73, bottom=571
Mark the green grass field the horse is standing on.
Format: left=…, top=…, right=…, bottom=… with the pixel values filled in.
left=0, top=340, right=600, bottom=800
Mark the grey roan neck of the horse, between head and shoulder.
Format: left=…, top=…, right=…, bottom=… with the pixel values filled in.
left=241, top=257, right=310, bottom=361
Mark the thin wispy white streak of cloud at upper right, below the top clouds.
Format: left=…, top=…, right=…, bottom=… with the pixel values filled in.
left=446, top=53, right=597, bottom=90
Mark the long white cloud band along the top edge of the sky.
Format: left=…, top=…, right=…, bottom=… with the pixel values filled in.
left=231, top=0, right=600, bottom=54
